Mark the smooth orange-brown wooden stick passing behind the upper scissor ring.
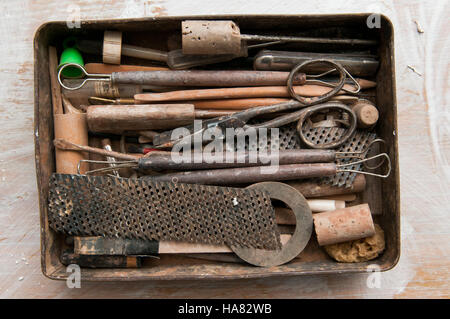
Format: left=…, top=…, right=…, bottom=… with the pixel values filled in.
left=134, top=80, right=375, bottom=102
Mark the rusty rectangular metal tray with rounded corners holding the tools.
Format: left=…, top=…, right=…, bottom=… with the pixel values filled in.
left=34, top=14, right=400, bottom=281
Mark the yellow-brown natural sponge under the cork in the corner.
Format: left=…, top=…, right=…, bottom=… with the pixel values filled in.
left=324, top=224, right=385, bottom=263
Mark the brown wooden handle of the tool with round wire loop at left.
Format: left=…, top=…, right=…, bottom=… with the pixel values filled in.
left=111, top=70, right=306, bottom=87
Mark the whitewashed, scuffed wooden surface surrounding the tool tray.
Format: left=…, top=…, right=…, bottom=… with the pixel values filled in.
left=0, top=0, right=450, bottom=298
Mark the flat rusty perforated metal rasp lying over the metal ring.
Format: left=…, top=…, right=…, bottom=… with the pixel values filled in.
left=48, top=174, right=281, bottom=250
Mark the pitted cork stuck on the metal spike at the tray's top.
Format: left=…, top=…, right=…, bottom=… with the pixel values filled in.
left=181, top=20, right=241, bottom=55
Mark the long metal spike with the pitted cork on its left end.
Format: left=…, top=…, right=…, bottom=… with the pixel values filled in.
left=181, top=20, right=377, bottom=55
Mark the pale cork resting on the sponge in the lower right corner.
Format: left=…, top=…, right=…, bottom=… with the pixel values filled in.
left=313, top=204, right=375, bottom=246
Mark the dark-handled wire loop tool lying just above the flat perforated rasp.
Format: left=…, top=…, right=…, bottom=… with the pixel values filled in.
left=143, top=153, right=391, bottom=185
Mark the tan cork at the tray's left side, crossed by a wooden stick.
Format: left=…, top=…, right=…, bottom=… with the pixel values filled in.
left=54, top=113, right=88, bottom=174
